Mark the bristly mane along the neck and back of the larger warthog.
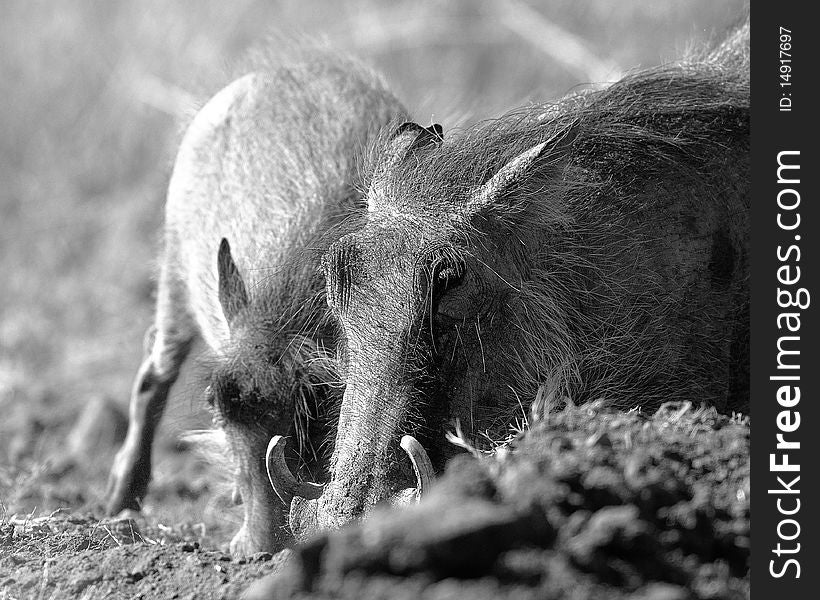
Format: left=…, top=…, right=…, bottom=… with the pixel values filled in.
left=359, top=29, right=749, bottom=224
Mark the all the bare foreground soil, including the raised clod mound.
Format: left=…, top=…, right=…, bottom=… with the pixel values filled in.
left=0, top=403, right=750, bottom=600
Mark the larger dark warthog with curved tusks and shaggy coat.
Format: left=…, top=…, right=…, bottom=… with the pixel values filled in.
left=282, top=19, right=749, bottom=534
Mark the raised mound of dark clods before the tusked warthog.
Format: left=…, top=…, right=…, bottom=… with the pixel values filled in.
left=249, top=403, right=750, bottom=600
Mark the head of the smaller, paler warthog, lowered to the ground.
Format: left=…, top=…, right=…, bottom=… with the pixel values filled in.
left=207, top=240, right=337, bottom=555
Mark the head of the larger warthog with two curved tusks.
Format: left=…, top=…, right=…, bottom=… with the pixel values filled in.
left=278, top=123, right=572, bottom=534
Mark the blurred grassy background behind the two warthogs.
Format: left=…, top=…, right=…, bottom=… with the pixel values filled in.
left=0, top=0, right=745, bottom=544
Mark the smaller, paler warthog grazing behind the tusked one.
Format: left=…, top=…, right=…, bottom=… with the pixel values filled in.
left=107, top=50, right=407, bottom=553
